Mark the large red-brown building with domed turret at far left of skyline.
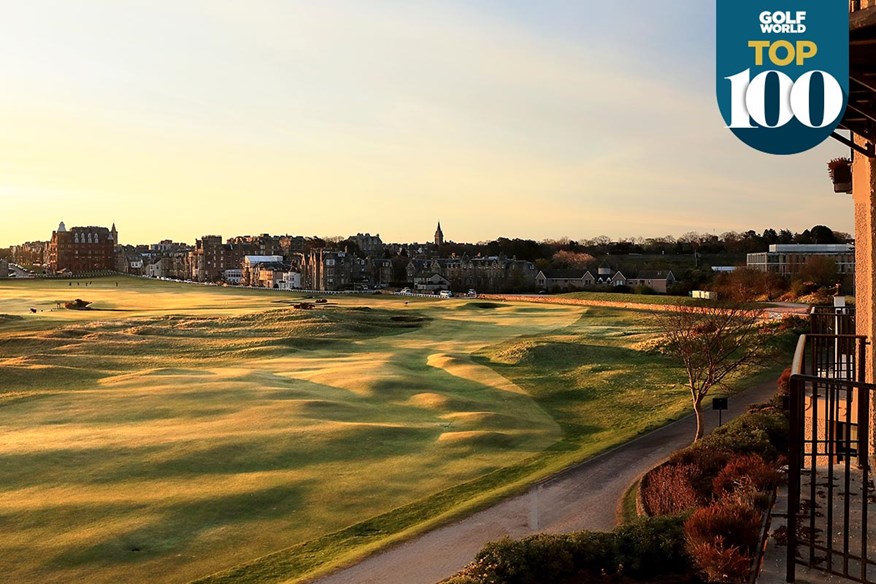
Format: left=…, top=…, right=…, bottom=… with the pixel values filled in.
left=46, top=221, right=119, bottom=274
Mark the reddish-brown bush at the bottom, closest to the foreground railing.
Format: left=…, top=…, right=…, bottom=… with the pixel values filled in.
left=684, top=499, right=760, bottom=582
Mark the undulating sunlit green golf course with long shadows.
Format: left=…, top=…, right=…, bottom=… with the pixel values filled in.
left=0, top=277, right=704, bottom=583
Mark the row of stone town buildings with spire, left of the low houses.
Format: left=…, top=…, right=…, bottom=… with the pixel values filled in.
left=34, top=222, right=536, bottom=292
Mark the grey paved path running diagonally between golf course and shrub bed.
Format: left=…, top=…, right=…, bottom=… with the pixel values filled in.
left=317, top=381, right=775, bottom=584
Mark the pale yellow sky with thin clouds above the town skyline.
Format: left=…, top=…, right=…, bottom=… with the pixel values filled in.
left=0, top=0, right=853, bottom=246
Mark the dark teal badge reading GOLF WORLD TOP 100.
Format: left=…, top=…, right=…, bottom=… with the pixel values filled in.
left=715, top=0, right=849, bottom=154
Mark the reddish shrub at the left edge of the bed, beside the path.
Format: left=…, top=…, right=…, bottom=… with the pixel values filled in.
left=640, top=463, right=702, bottom=515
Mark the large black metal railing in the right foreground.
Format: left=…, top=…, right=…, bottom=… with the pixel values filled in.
left=787, top=334, right=876, bottom=584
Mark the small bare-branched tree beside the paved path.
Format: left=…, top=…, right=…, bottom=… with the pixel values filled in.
left=657, top=303, right=771, bottom=442
